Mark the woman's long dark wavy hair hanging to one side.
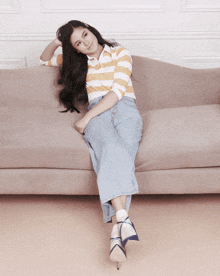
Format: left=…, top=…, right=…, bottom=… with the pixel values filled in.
left=57, top=20, right=118, bottom=113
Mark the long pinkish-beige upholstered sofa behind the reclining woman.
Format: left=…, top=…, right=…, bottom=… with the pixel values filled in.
left=0, top=56, right=220, bottom=195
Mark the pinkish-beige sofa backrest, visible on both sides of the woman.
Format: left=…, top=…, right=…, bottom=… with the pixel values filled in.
left=0, top=56, right=220, bottom=114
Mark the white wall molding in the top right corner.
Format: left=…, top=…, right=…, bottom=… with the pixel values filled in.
left=181, top=0, right=220, bottom=12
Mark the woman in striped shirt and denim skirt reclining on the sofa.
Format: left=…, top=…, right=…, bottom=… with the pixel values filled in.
left=40, top=20, right=142, bottom=268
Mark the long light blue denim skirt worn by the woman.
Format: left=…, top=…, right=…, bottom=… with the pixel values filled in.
left=84, top=96, right=143, bottom=222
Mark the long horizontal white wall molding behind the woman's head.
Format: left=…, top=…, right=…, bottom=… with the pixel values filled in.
left=0, top=31, right=220, bottom=41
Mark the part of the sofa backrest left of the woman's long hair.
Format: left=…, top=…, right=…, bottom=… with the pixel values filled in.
left=0, top=66, right=62, bottom=110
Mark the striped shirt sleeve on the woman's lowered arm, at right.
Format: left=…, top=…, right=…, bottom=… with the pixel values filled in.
left=112, top=47, right=132, bottom=100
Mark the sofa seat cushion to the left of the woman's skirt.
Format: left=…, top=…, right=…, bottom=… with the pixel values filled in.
left=1, top=105, right=93, bottom=170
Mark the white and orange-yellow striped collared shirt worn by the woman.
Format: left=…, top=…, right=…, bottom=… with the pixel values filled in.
left=41, top=45, right=135, bottom=102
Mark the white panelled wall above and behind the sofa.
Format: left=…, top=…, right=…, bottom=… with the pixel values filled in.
left=0, top=0, right=220, bottom=68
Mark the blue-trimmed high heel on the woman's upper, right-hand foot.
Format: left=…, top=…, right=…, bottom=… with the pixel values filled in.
left=117, top=217, right=139, bottom=246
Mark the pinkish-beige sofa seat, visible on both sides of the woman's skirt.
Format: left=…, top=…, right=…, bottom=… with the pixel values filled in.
left=1, top=97, right=220, bottom=172
